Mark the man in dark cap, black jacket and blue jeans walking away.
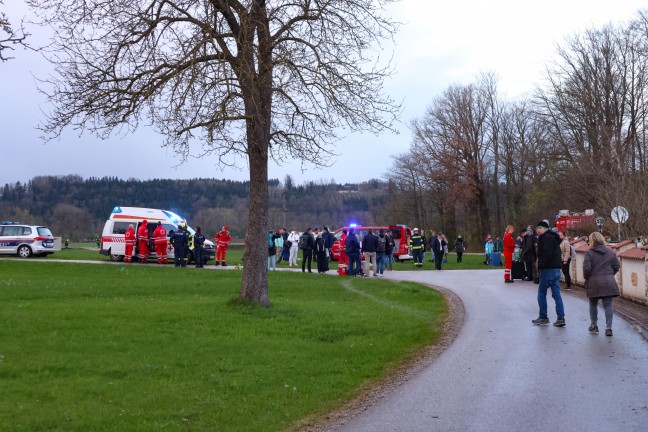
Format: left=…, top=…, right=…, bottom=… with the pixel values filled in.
left=531, top=220, right=565, bottom=327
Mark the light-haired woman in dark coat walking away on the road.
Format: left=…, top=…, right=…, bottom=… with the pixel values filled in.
left=583, top=232, right=621, bottom=336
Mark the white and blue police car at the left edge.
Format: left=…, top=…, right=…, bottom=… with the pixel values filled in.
left=0, top=222, right=54, bottom=258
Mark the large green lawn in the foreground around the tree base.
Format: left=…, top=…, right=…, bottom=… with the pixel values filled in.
left=0, top=260, right=447, bottom=432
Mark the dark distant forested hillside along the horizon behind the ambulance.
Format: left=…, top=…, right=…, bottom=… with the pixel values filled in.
left=0, top=175, right=392, bottom=241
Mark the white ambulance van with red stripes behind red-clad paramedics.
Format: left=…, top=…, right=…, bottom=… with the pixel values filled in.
left=99, top=206, right=216, bottom=263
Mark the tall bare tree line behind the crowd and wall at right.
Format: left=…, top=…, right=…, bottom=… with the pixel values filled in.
left=386, top=10, right=648, bottom=245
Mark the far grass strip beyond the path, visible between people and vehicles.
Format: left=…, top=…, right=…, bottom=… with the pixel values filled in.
left=21, top=243, right=501, bottom=271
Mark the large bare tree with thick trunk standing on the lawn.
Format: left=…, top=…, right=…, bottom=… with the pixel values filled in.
left=27, top=0, right=399, bottom=306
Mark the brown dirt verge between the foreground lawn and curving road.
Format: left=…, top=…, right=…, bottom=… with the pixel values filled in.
left=292, top=285, right=465, bottom=432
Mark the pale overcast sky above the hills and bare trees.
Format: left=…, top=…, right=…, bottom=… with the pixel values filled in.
left=0, top=0, right=646, bottom=184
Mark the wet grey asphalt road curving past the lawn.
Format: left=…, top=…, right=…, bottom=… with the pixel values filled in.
left=340, top=271, right=648, bottom=432
